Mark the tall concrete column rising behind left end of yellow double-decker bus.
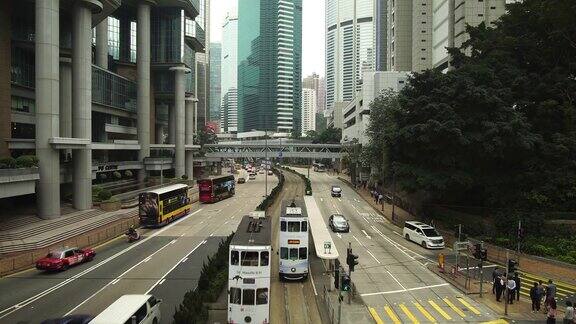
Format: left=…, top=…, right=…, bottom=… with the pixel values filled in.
left=136, top=1, right=150, bottom=181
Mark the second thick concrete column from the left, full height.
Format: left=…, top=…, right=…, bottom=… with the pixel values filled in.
left=72, top=0, right=102, bottom=210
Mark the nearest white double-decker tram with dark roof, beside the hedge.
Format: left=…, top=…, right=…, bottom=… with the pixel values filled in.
left=228, top=212, right=272, bottom=324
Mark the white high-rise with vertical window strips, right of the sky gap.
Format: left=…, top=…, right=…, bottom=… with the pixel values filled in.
left=326, top=0, right=385, bottom=109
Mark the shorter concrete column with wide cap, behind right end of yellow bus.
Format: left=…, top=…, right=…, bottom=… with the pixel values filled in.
left=169, top=67, right=190, bottom=178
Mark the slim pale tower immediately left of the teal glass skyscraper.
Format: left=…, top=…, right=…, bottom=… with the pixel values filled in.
left=220, top=9, right=238, bottom=133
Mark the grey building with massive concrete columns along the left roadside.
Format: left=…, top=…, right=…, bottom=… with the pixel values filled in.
left=0, top=0, right=205, bottom=218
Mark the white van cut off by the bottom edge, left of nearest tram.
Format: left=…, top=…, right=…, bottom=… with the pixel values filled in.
left=90, top=295, right=162, bottom=324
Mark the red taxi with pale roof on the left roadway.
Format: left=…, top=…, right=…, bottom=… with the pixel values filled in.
left=36, top=248, right=96, bottom=271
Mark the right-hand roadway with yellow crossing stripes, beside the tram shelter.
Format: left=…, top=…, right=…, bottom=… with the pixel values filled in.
left=297, top=169, right=498, bottom=323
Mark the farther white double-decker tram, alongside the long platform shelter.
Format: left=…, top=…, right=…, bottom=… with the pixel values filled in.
left=278, top=201, right=308, bottom=280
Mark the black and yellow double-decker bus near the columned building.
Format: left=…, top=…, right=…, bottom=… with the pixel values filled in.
left=138, top=184, right=192, bottom=227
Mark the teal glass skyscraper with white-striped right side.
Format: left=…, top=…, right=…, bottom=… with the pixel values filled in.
left=238, top=0, right=302, bottom=133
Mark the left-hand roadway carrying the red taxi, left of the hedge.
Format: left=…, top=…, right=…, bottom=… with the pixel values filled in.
left=0, top=174, right=277, bottom=324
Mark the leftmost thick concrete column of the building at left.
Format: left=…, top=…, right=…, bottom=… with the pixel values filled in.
left=35, top=0, right=60, bottom=219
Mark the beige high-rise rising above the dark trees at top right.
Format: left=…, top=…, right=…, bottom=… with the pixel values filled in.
left=432, top=0, right=514, bottom=70
